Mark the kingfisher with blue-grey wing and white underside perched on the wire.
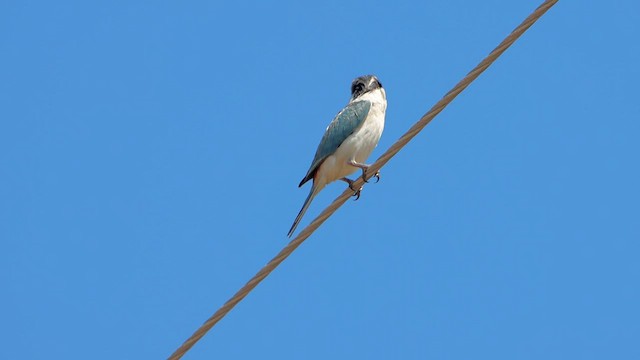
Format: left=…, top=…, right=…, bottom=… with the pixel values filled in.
left=288, top=75, right=387, bottom=237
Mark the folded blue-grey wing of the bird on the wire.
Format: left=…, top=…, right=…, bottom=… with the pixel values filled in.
left=298, top=100, right=371, bottom=186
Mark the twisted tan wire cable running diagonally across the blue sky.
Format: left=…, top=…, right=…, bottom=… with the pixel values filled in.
left=169, top=0, right=558, bottom=360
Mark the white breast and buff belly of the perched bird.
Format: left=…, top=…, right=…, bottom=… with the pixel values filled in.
left=316, top=88, right=387, bottom=187
